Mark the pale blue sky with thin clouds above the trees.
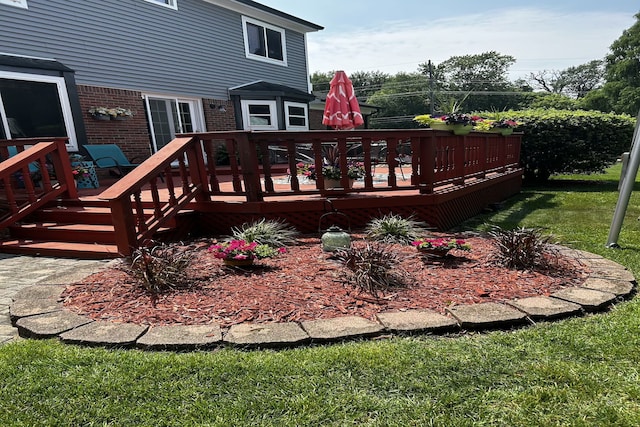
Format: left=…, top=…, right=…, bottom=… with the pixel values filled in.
left=258, top=0, right=640, bottom=80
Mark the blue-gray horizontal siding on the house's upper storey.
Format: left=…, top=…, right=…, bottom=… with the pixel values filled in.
left=0, top=0, right=308, bottom=99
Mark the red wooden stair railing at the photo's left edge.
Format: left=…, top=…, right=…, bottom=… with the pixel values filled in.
left=0, top=138, right=77, bottom=230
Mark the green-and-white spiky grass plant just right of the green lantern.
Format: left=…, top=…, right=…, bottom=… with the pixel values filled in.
left=365, top=213, right=427, bottom=245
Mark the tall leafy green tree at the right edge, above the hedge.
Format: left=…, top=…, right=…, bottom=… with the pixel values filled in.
left=584, top=13, right=640, bottom=116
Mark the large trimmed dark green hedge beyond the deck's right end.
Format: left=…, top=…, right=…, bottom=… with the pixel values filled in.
left=508, top=109, right=635, bottom=181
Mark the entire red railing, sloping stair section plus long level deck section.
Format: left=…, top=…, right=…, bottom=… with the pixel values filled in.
left=101, top=129, right=520, bottom=255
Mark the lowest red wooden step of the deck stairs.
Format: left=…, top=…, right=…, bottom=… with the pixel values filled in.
left=0, top=239, right=120, bottom=259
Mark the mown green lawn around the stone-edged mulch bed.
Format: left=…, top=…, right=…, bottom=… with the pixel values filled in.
left=0, top=163, right=640, bottom=426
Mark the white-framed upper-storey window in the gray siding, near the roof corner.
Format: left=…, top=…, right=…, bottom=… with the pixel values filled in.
left=242, top=16, right=287, bottom=66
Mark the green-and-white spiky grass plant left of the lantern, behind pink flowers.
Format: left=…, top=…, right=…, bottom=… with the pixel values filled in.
left=231, top=218, right=298, bottom=248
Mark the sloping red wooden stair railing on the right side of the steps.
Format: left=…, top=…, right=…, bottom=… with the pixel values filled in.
left=100, top=137, right=209, bottom=256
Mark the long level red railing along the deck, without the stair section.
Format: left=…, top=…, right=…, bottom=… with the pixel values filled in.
left=185, top=129, right=521, bottom=202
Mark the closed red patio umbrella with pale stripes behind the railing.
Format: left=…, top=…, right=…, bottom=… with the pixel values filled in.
left=322, top=71, right=364, bottom=129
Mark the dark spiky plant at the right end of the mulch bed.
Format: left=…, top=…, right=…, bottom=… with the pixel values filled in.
left=489, top=226, right=558, bottom=270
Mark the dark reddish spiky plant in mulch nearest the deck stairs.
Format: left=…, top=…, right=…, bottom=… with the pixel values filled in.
left=127, top=244, right=193, bottom=294
